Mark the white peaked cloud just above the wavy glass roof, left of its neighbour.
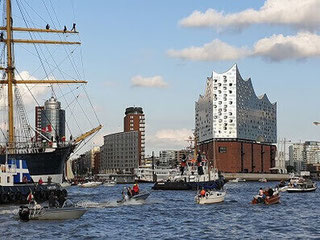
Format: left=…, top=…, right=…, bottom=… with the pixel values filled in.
left=167, top=39, right=249, bottom=61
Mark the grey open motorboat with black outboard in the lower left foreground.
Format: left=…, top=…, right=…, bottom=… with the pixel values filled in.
left=19, top=200, right=87, bottom=221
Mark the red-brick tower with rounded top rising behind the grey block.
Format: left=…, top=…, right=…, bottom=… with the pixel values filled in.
left=124, top=107, right=145, bottom=166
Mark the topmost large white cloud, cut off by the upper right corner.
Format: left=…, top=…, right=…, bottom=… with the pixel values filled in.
left=179, top=0, right=320, bottom=30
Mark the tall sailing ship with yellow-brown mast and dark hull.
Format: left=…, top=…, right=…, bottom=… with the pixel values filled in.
left=0, top=0, right=102, bottom=183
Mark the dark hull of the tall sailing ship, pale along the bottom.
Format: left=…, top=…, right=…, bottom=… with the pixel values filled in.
left=0, top=145, right=75, bottom=183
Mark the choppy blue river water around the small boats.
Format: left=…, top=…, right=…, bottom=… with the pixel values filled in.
left=0, top=182, right=320, bottom=240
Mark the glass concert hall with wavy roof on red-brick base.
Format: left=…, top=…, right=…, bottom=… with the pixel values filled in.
left=195, top=64, right=277, bottom=173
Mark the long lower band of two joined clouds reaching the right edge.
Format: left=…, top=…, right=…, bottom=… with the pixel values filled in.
left=168, top=32, right=320, bottom=61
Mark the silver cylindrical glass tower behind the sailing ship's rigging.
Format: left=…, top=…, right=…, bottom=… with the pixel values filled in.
left=41, top=97, right=66, bottom=141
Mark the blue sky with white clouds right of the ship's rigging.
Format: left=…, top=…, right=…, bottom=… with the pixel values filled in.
left=3, top=0, right=320, bottom=155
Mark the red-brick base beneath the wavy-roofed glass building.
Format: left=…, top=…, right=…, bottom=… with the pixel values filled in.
left=199, top=139, right=276, bottom=173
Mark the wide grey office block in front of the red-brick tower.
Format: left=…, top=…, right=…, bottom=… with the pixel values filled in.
left=100, top=131, right=140, bottom=173
